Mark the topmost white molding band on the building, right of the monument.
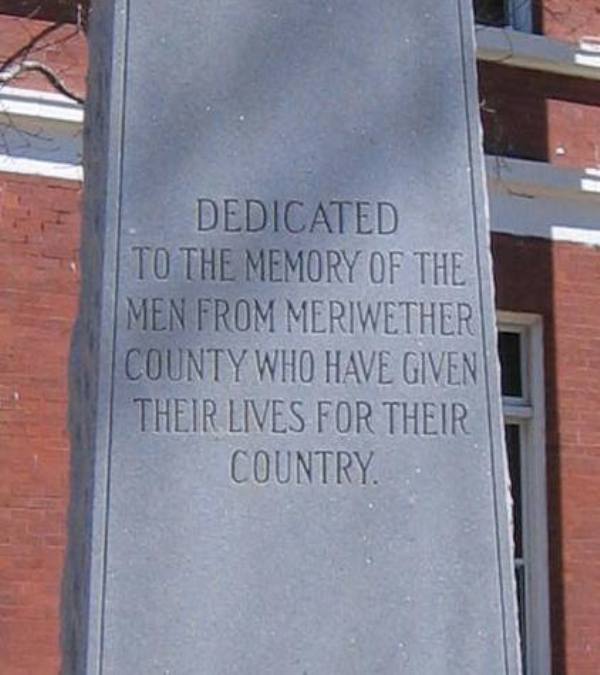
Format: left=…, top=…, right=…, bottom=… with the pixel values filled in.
left=475, top=24, right=600, bottom=80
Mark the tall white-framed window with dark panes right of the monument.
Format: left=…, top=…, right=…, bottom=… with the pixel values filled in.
left=498, top=313, right=550, bottom=675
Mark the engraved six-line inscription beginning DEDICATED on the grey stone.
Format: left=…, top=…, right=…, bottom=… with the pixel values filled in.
left=119, top=195, right=481, bottom=488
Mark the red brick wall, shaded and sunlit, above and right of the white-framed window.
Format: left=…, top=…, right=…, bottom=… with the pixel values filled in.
left=493, top=235, right=600, bottom=675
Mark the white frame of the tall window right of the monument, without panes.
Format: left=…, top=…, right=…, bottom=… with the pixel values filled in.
left=497, top=312, right=551, bottom=675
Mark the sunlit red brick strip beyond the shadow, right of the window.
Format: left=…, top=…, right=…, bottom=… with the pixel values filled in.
left=553, top=240, right=600, bottom=675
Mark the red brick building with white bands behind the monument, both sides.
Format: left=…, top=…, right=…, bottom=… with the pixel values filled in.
left=0, top=0, right=600, bottom=675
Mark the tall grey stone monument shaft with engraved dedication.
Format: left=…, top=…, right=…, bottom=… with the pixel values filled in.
left=66, top=0, right=518, bottom=675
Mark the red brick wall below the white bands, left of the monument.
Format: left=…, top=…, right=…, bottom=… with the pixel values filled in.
left=0, top=174, right=80, bottom=675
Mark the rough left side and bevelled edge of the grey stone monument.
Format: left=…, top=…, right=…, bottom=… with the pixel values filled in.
left=61, top=0, right=129, bottom=675
